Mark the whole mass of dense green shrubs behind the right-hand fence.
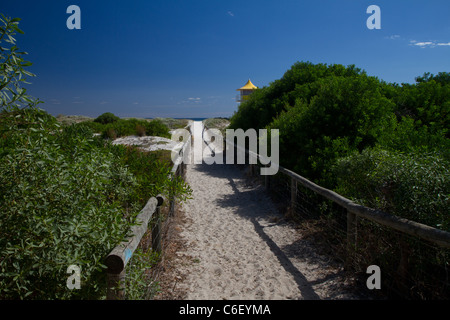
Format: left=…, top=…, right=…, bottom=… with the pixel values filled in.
left=230, top=62, right=450, bottom=231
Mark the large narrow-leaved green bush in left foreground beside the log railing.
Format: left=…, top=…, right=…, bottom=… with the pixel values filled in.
left=0, top=110, right=138, bottom=299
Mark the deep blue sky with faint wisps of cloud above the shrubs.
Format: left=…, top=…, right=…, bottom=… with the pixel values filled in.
left=0, top=0, right=450, bottom=117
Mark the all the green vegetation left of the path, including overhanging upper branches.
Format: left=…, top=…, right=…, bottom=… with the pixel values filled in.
left=0, top=16, right=189, bottom=299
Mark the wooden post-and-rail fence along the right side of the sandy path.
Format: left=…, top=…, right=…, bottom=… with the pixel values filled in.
left=204, top=127, right=450, bottom=298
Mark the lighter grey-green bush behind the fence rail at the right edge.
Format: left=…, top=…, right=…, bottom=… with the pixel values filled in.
left=334, top=149, right=450, bottom=231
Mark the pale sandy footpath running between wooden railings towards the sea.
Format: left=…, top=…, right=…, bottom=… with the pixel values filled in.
left=172, top=122, right=357, bottom=300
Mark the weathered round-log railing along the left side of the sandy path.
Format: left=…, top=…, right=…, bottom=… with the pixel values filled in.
left=105, top=125, right=191, bottom=300
